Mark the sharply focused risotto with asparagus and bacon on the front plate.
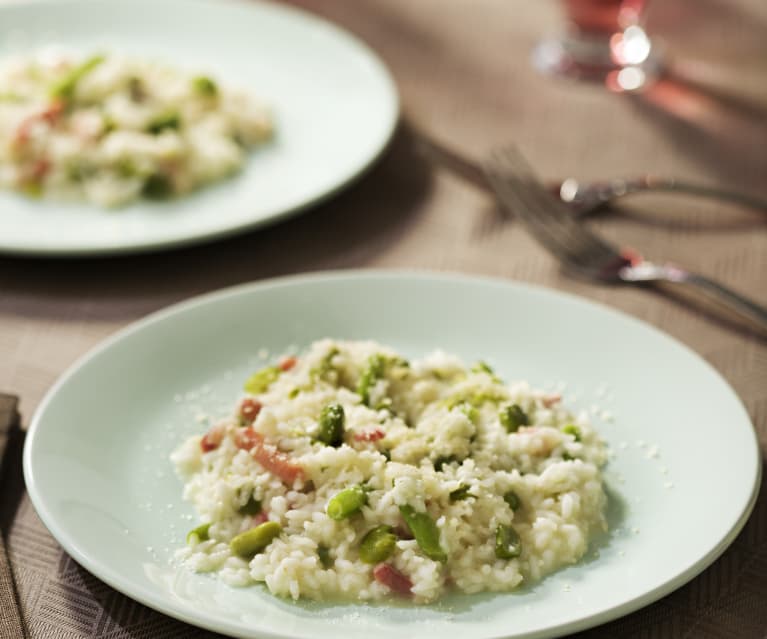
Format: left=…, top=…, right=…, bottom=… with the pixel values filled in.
left=172, top=339, right=607, bottom=604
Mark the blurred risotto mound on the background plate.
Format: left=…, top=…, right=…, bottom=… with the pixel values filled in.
left=0, top=51, right=272, bottom=207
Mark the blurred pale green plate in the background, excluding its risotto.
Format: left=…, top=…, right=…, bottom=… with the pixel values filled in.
left=0, top=0, right=399, bottom=256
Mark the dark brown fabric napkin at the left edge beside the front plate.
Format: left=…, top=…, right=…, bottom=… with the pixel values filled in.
left=0, top=393, right=26, bottom=639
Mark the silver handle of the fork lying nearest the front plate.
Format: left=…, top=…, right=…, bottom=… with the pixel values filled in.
left=620, top=262, right=767, bottom=334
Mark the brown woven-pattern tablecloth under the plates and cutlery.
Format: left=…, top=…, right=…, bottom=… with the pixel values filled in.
left=0, top=0, right=767, bottom=639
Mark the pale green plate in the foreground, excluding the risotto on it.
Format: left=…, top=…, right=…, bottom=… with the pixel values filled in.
left=24, top=271, right=761, bottom=639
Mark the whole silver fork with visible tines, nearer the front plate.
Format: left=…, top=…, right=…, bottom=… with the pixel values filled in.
left=484, top=147, right=767, bottom=332
